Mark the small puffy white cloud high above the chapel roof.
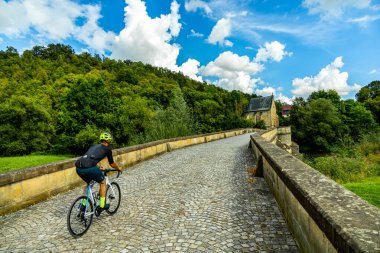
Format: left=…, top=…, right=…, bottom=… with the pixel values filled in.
left=255, top=41, right=293, bottom=62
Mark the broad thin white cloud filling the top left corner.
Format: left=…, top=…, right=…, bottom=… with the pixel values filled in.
left=0, top=0, right=115, bottom=51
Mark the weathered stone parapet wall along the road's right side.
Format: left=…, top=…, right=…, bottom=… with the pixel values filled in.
left=251, top=130, right=380, bottom=252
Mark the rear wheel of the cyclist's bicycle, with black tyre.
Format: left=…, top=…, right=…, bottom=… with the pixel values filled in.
left=67, top=196, right=94, bottom=237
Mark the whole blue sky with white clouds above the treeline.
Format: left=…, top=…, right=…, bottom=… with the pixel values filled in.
left=0, top=0, right=380, bottom=102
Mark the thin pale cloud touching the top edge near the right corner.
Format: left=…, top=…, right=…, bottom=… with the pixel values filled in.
left=302, top=0, right=371, bottom=18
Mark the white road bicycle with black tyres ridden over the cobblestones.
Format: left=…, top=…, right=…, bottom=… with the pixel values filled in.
left=67, top=169, right=121, bottom=237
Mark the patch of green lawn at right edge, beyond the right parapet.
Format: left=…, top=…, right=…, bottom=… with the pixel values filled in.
left=343, top=177, right=380, bottom=208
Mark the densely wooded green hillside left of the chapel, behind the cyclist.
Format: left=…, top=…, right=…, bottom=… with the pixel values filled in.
left=0, top=44, right=254, bottom=156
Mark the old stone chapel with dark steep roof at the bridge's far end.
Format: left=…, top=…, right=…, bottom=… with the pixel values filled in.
left=245, top=95, right=278, bottom=127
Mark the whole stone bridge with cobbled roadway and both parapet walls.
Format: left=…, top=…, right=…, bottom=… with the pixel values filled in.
left=0, top=128, right=380, bottom=252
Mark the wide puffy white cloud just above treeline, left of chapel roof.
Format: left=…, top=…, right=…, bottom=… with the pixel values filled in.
left=201, top=51, right=263, bottom=93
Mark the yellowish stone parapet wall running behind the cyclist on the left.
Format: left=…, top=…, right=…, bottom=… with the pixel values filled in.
left=0, top=129, right=255, bottom=215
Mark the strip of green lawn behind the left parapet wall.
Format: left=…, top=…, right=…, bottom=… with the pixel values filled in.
left=0, top=155, right=73, bottom=173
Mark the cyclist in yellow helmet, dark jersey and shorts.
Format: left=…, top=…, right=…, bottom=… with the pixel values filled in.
left=75, top=132, right=121, bottom=212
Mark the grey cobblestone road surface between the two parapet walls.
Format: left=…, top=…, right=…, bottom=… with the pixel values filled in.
left=0, top=134, right=298, bottom=252
